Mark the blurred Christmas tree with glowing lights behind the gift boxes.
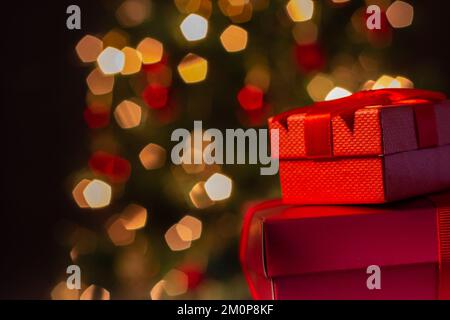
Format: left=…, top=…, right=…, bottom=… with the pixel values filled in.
left=52, top=0, right=436, bottom=299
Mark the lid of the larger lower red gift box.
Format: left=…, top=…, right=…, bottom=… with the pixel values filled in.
left=241, top=192, right=450, bottom=277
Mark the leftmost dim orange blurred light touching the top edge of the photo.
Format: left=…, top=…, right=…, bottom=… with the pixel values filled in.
left=116, top=0, right=151, bottom=27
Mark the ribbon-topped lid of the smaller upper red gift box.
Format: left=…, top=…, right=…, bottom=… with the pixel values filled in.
left=268, top=89, right=450, bottom=159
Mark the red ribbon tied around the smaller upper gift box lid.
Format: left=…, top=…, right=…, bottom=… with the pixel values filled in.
left=273, top=88, right=446, bottom=158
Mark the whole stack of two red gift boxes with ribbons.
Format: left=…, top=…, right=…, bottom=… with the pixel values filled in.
left=240, top=89, right=450, bottom=299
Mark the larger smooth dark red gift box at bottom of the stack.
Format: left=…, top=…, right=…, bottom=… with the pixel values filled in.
left=240, top=191, right=450, bottom=300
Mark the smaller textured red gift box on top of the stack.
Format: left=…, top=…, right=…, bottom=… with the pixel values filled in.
left=269, top=89, right=450, bottom=204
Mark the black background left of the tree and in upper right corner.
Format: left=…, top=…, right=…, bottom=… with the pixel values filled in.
left=0, top=0, right=450, bottom=299
